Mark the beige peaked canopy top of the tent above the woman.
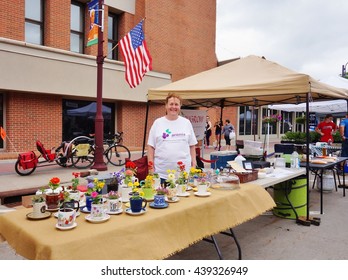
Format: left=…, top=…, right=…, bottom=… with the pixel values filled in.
left=148, top=55, right=348, bottom=107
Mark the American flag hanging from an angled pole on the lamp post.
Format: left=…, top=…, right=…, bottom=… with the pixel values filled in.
left=119, top=20, right=152, bottom=88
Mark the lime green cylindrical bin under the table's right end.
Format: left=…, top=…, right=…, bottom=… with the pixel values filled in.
left=273, top=176, right=307, bottom=220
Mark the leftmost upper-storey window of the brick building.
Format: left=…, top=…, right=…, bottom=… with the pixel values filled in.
left=25, top=0, right=44, bottom=45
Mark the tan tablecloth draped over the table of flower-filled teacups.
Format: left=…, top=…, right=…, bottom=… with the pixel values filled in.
left=0, top=183, right=275, bottom=260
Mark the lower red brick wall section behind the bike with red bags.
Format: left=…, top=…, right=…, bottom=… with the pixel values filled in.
left=6, top=93, right=62, bottom=152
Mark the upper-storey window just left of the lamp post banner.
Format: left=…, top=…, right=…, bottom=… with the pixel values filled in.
left=70, top=1, right=85, bottom=53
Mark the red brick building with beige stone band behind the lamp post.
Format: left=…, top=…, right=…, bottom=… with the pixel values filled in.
left=0, top=0, right=217, bottom=158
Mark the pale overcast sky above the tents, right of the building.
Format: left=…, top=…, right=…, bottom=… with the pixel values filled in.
left=216, top=0, right=348, bottom=79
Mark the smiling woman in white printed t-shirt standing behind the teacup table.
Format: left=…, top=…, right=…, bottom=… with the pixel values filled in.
left=147, top=93, right=197, bottom=180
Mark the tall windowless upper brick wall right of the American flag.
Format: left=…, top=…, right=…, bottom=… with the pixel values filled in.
left=145, top=0, right=217, bottom=81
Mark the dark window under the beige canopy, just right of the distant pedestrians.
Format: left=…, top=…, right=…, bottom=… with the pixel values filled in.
left=239, top=106, right=259, bottom=135
